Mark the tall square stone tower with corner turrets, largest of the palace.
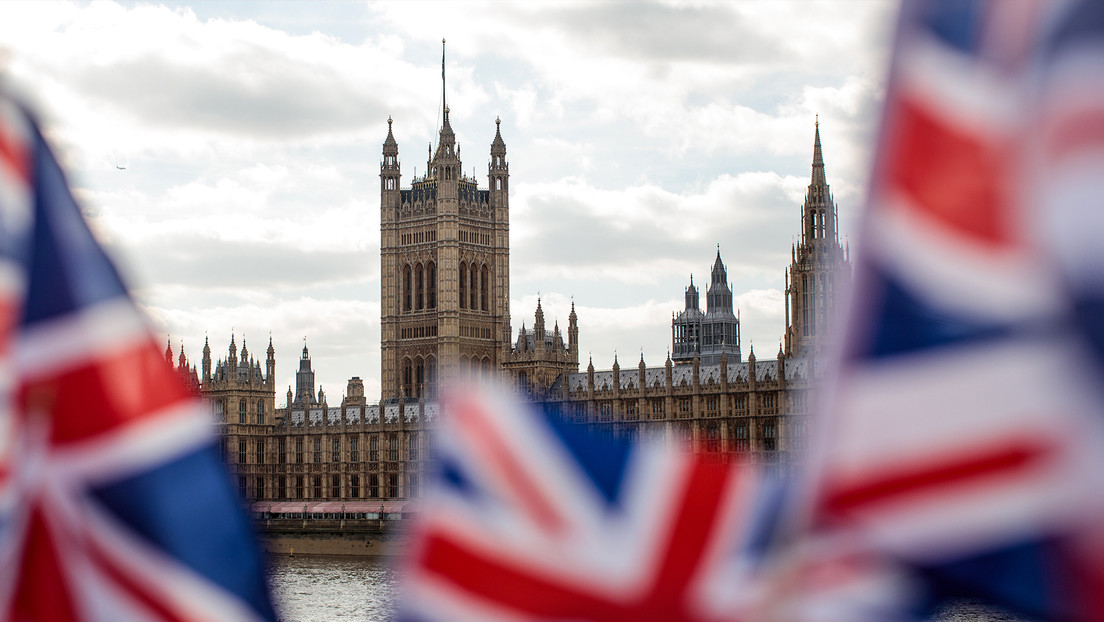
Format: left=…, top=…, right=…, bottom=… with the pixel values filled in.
left=380, top=51, right=510, bottom=399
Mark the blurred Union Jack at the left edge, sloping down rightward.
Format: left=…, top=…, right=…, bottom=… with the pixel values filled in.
left=0, top=96, right=275, bottom=621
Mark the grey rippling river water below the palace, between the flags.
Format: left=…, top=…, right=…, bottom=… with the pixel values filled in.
left=272, top=556, right=1017, bottom=622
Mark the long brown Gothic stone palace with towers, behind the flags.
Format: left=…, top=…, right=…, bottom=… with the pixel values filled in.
left=164, top=86, right=851, bottom=513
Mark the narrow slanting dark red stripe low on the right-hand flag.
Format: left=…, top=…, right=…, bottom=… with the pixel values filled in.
left=821, top=441, right=1053, bottom=516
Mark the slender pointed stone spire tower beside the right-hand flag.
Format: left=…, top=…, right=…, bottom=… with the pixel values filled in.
left=785, top=122, right=851, bottom=356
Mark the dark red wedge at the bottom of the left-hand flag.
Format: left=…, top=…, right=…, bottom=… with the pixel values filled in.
left=12, top=505, right=77, bottom=622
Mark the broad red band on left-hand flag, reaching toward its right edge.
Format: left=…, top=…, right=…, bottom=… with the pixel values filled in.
left=20, top=340, right=187, bottom=444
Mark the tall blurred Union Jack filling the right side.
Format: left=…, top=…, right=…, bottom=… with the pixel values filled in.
left=806, top=0, right=1104, bottom=620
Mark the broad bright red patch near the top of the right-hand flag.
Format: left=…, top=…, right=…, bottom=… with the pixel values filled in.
left=885, top=97, right=1013, bottom=246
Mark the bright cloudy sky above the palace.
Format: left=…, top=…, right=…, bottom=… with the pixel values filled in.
left=0, top=0, right=895, bottom=405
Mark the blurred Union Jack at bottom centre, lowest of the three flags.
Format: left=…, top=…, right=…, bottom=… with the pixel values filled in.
left=400, top=393, right=786, bottom=621
